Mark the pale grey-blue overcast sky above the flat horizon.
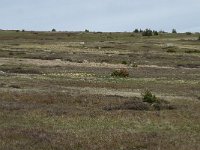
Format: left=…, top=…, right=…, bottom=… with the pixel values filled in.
left=0, top=0, right=200, bottom=32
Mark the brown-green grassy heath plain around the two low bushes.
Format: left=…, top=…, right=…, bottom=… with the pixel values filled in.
left=0, top=31, right=200, bottom=150
